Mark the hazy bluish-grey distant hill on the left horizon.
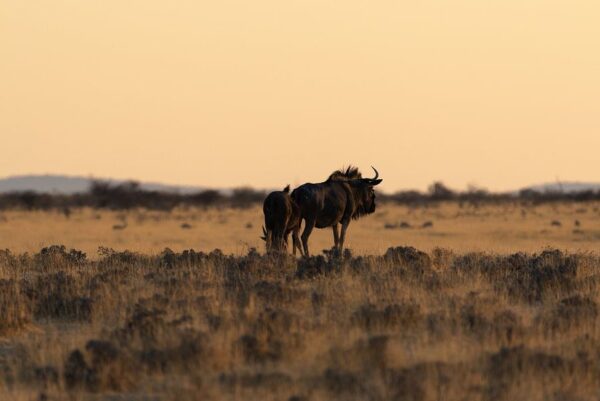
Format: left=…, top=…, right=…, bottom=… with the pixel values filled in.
left=0, top=174, right=206, bottom=195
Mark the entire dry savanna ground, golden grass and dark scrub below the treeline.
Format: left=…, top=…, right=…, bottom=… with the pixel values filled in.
left=0, top=202, right=600, bottom=401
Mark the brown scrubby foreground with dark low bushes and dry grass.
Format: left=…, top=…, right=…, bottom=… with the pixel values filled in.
left=0, top=246, right=600, bottom=401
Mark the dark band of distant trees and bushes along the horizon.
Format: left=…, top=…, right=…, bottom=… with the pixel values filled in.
left=0, top=181, right=600, bottom=211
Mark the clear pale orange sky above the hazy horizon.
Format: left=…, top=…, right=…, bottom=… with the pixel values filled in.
left=0, top=0, right=600, bottom=191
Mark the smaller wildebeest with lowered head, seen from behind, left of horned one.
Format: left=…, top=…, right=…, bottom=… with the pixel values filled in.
left=261, top=185, right=302, bottom=255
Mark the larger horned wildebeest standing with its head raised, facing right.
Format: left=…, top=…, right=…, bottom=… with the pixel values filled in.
left=292, top=166, right=382, bottom=256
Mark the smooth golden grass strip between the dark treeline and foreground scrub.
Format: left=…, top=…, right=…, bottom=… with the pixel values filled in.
left=0, top=203, right=600, bottom=257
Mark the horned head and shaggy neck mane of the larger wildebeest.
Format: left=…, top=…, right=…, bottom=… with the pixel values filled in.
left=329, top=166, right=383, bottom=219
